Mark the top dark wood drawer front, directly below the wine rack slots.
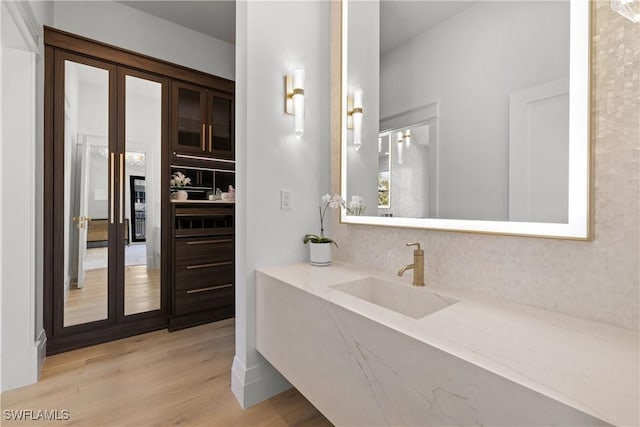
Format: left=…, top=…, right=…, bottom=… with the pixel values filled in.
left=176, top=236, right=235, bottom=270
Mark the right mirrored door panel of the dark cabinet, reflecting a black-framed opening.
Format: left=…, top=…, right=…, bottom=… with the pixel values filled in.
left=123, top=75, right=162, bottom=315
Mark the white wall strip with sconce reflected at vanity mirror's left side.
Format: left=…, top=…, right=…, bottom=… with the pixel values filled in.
left=346, top=1, right=380, bottom=215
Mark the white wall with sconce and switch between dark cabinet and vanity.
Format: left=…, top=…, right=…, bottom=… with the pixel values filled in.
left=232, top=1, right=330, bottom=407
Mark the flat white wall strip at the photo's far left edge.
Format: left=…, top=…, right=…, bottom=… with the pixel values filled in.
left=1, top=36, right=35, bottom=390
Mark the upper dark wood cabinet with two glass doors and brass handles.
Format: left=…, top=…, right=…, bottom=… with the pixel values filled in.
left=172, top=81, right=235, bottom=160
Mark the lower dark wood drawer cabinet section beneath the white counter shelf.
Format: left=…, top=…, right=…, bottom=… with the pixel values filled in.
left=169, top=201, right=235, bottom=330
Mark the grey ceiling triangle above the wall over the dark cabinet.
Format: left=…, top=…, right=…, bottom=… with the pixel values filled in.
left=120, top=0, right=236, bottom=45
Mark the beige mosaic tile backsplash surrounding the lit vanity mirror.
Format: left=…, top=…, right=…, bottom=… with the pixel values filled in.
left=331, top=1, right=640, bottom=330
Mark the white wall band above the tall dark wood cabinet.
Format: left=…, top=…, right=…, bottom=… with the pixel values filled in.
left=53, top=1, right=235, bottom=80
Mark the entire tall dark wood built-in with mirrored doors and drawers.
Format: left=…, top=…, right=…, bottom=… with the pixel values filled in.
left=43, top=27, right=235, bottom=354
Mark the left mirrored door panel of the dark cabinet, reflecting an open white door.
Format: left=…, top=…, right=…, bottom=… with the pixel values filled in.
left=63, top=61, right=110, bottom=326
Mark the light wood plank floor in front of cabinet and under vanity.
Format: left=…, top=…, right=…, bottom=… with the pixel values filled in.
left=1, top=319, right=331, bottom=427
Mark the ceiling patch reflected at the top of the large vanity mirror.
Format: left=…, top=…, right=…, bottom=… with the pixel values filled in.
left=380, top=0, right=476, bottom=54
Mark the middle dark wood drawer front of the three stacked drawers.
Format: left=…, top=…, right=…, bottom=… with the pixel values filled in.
left=176, top=261, right=235, bottom=290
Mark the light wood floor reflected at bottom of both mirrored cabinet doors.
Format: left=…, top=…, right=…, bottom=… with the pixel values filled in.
left=64, top=265, right=160, bottom=326
